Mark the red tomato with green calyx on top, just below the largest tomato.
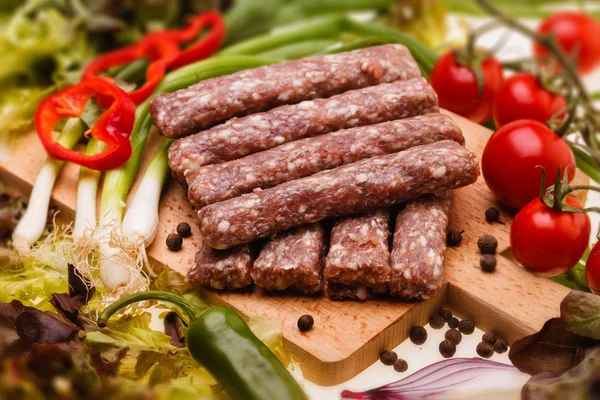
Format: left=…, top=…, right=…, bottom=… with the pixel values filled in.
left=510, top=197, right=591, bottom=276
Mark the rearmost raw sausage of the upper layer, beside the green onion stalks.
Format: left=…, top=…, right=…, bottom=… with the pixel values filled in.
left=150, top=44, right=421, bottom=138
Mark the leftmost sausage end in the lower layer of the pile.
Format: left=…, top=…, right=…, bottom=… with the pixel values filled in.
left=187, top=243, right=252, bottom=289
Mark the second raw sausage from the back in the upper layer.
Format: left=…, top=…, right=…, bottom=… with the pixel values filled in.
left=169, top=77, right=438, bottom=185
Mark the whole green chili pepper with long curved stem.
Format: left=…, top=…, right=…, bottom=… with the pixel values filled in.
left=98, top=291, right=308, bottom=400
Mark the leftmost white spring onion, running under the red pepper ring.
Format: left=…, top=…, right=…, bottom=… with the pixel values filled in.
left=12, top=118, right=85, bottom=252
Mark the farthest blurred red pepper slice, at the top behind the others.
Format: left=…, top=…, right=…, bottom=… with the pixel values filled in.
left=146, top=11, right=225, bottom=70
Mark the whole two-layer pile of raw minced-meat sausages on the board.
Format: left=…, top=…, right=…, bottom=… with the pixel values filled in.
left=151, top=45, right=479, bottom=299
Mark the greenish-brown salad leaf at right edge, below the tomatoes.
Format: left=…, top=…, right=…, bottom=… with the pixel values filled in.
left=560, top=290, right=600, bottom=340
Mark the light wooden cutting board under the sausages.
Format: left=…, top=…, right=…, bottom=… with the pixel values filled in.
left=0, top=111, right=587, bottom=385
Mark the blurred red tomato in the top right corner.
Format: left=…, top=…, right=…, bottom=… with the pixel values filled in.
left=533, top=11, right=600, bottom=74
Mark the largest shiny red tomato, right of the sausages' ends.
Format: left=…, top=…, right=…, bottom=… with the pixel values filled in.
left=481, top=119, right=575, bottom=208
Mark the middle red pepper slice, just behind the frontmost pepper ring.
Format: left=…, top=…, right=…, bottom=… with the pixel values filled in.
left=83, top=35, right=180, bottom=108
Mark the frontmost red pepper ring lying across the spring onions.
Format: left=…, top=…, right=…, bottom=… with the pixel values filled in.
left=35, top=78, right=135, bottom=171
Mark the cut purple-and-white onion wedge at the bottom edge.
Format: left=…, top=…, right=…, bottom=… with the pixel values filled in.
left=342, top=358, right=530, bottom=400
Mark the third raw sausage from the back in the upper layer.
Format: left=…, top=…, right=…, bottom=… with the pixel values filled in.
left=188, top=114, right=464, bottom=209
